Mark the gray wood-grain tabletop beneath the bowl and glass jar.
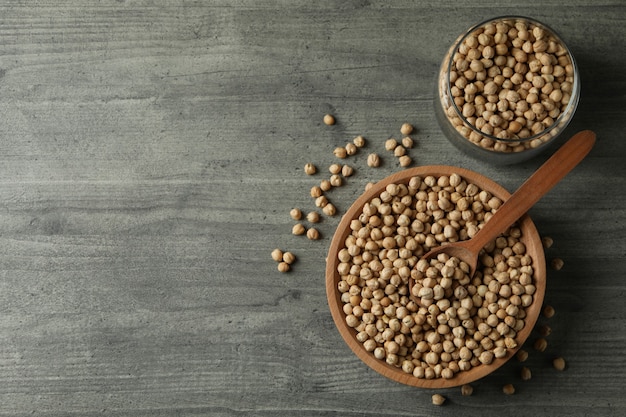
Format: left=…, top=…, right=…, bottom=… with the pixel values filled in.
left=0, top=0, right=626, bottom=416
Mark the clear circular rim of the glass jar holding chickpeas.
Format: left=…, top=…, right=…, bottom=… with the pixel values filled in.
left=445, top=15, right=580, bottom=143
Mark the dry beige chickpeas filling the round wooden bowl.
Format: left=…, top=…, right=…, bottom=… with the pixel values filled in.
left=337, top=174, right=535, bottom=379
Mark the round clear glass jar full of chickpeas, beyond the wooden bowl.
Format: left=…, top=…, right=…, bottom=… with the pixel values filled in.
left=435, top=16, right=580, bottom=165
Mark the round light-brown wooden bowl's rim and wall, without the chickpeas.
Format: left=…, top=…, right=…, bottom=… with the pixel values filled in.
left=326, top=165, right=546, bottom=388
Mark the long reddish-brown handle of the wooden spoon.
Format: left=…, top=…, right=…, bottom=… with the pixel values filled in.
left=468, top=130, right=596, bottom=250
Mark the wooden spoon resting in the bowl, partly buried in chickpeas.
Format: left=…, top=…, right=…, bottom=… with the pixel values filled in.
left=409, top=130, right=596, bottom=303
